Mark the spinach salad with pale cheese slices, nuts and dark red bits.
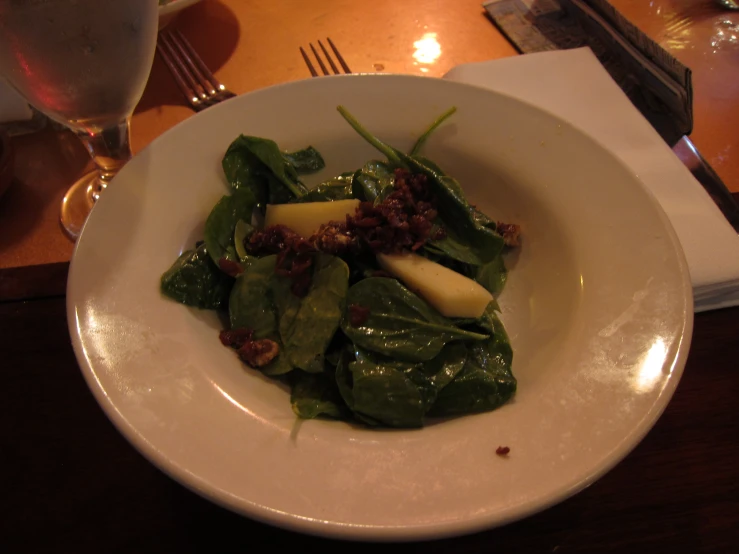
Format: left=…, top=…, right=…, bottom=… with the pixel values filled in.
left=161, top=106, right=518, bottom=427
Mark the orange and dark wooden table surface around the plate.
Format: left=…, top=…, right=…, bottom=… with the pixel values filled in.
left=0, top=0, right=739, bottom=553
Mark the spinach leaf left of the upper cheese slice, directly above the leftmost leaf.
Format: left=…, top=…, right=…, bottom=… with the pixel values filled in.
left=203, top=189, right=256, bottom=265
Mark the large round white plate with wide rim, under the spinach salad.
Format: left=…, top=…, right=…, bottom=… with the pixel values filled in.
left=68, top=75, right=692, bottom=539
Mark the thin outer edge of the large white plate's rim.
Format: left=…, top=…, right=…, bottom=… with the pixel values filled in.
left=66, top=73, right=694, bottom=542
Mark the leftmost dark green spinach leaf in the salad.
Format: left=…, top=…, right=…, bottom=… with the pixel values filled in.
left=160, top=244, right=234, bottom=310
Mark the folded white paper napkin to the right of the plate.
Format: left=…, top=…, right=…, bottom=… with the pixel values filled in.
left=444, top=48, right=739, bottom=312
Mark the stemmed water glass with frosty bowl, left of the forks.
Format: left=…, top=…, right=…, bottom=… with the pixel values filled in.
left=0, top=0, right=159, bottom=239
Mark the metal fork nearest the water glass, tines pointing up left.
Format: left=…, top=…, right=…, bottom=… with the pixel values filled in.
left=157, top=27, right=236, bottom=112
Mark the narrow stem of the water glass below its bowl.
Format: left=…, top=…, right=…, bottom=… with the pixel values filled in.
left=77, top=118, right=131, bottom=202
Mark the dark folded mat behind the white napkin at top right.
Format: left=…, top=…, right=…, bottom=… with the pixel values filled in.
left=483, top=0, right=693, bottom=146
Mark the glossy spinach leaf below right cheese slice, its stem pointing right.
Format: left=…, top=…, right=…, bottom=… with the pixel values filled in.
left=341, top=277, right=488, bottom=361
